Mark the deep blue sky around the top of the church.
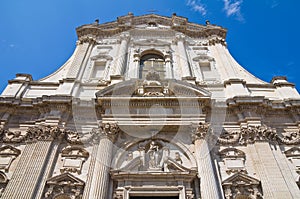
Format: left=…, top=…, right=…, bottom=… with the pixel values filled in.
left=0, top=0, right=300, bottom=92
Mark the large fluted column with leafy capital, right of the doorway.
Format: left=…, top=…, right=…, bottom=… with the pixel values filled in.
left=192, top=123, right=223, bottom=198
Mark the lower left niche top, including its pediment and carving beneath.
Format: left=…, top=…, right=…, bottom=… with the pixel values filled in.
left=44, top=173, right=85, bottom=199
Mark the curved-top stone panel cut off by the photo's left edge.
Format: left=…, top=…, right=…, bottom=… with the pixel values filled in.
left=0, top=145, right=21, bottom=172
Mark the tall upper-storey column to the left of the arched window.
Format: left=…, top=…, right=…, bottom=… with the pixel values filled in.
left=114, top=34, right=129, bottom=75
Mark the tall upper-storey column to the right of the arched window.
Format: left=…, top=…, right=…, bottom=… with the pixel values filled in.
left=176, top=34, right=191, bottom=77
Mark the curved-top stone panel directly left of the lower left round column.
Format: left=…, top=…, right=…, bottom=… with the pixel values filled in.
left=60, top=146, right=89, bottom=174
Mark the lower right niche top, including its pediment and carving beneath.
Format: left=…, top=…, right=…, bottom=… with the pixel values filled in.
left=222, top=172, right=263, bottom=199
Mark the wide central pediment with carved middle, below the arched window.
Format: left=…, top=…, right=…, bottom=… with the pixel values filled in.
left=96, top=80, right=211, bottom=98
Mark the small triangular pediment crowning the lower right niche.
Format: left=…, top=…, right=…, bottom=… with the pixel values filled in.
left=222, top=172, right=260, bottom=186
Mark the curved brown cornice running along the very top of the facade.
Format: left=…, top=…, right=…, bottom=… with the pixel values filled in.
left=76, top=13, right=227, bottom=40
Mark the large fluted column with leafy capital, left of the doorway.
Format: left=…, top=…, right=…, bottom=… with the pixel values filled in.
left=84, top=123, right=119, bottom=199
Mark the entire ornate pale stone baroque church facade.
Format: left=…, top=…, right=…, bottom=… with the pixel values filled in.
left=0, top=13, right=300, bottom=199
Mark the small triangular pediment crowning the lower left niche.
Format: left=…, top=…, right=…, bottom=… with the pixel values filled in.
left=47, top=173, right=84, bottom=186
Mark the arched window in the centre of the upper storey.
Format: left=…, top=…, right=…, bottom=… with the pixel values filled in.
left=139, top=51, right=166, bottom=79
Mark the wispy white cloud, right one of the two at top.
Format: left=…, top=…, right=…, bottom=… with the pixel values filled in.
left=223, top=0, right=244, bottom=21
